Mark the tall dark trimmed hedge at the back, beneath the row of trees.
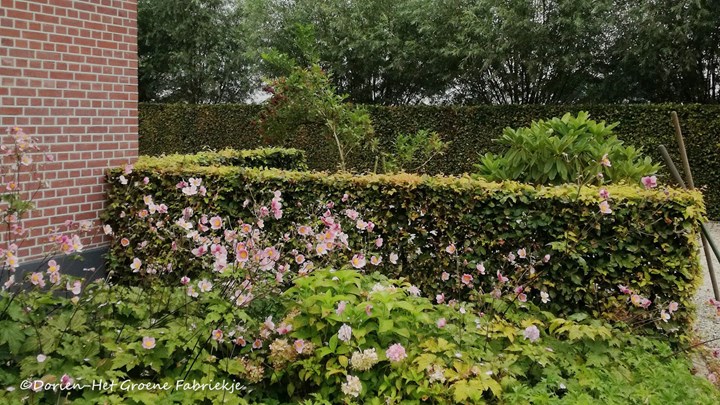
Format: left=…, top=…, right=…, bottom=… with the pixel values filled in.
left=140, top=104, right=720, bottom=219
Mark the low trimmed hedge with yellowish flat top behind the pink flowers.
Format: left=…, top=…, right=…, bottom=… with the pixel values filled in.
left=104, top=153, right=704, bottom=330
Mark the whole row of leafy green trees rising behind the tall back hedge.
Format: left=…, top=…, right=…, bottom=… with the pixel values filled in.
left=138, top=0, right=720, bottom=105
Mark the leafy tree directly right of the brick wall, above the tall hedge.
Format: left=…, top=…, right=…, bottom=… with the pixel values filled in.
left=138, top=0, right=255, bottom=103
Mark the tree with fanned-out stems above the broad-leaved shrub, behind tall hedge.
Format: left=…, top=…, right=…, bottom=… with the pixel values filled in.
left=451, top=0, right=611, bottom=104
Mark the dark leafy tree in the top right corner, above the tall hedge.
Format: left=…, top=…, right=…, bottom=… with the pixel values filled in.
left=595, top=0, right=720, bottom=102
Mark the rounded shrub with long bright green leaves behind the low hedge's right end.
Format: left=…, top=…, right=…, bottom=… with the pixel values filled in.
left=477, top=112, right=659, bottom=184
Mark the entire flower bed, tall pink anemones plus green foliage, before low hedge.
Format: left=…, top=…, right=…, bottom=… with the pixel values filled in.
left=0, top=125, right=720, bottom=404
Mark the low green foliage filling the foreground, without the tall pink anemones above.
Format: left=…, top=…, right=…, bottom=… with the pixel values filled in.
left=5, top=270, right=720, bottom=404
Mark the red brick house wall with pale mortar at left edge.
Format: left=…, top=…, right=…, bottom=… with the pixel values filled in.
left=0, top=0, right=138, bottom=258
